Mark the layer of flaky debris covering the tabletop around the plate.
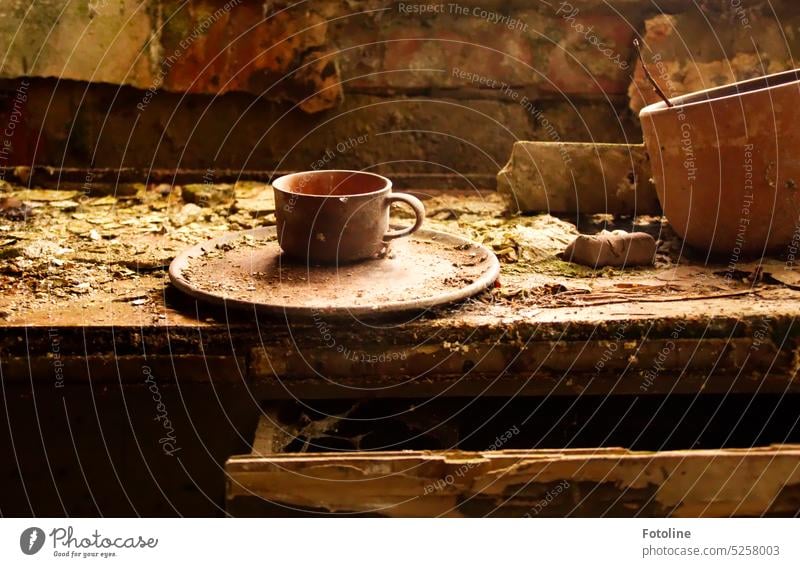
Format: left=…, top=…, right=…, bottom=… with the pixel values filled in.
left=0, top=181, right=800, bottom=323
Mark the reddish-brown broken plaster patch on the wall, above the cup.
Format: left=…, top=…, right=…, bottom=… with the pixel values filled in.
left=162, top=2, right=342, bottom=113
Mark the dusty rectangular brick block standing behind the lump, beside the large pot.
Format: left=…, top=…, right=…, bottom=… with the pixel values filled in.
left=497, top=142, right=661, bottom=215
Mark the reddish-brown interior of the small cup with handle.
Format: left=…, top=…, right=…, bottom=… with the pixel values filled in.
left=274, top=170, right=390, bottom=197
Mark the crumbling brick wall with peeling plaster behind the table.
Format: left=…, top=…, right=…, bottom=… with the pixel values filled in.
left=0, top=0, right=798, bottom=184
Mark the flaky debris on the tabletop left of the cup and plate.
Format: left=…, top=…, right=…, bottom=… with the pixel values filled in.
left=0, top=182, right=275, bottom=316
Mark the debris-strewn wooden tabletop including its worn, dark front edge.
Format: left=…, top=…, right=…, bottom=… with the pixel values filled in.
left=0, top=182, right=800, bottom=397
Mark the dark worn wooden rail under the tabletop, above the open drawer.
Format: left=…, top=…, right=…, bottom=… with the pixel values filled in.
left=248, top=338, right=800, bottom=399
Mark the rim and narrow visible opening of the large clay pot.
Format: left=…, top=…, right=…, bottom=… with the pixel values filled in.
left=639, top=68, right=800, bottom=117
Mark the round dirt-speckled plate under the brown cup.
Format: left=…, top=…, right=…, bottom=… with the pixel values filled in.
left=169, top=227, right=500, bottom=317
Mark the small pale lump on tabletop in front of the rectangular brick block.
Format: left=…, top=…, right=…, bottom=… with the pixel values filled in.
left=564, top=230, right=656, bottom=268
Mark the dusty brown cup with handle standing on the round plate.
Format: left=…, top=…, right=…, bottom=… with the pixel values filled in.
left=272, top=170, right=425, bottom=263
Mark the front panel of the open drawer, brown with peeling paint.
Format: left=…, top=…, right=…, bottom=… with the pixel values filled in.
left=225, top=445, right=800, bottom=517
